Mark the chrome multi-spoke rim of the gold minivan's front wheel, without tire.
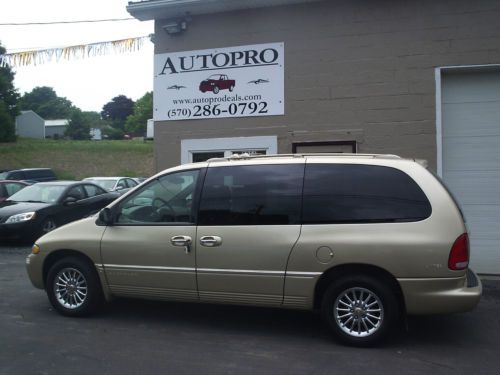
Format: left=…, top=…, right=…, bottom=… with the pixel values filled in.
left=54, top=268, right=87, bottom=309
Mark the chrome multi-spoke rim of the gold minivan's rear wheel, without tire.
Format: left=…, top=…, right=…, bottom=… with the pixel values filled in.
left=333, top=288, right=384, bottom=337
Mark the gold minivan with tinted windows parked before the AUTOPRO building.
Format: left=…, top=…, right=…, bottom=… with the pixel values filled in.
left=26, top=154, right=482, bottom=346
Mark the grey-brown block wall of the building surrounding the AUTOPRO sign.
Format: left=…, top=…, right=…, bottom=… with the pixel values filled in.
left=150, top=0, right=500, bottom=170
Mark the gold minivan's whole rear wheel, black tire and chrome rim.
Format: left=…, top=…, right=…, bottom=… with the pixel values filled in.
left=321, top=275, right=400, bottom=347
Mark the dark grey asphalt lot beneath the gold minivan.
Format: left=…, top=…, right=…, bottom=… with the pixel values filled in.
left=0, top=246, right=500, bottom=375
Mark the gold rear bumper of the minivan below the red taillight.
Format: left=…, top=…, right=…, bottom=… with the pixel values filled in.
left=398, top=269, right=483, bottom=315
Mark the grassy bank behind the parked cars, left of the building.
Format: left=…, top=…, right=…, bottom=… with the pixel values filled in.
left=0, top=139, right=154, bottom=180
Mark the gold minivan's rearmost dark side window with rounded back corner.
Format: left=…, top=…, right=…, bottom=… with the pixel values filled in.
left=302, top=164, right=432, bottom=224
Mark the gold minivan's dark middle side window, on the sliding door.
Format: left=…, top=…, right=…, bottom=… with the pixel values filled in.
left=198, top=164, right=304, bottom=226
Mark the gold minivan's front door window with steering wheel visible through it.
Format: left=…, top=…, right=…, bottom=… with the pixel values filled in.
left=116, top=170, right=200, bottom=225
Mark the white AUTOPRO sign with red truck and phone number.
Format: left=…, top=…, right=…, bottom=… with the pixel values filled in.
left=153, top=43, right=284, bottom=121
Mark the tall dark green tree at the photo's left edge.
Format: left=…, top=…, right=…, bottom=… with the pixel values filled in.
left=0, top=45, right=19, bottom=142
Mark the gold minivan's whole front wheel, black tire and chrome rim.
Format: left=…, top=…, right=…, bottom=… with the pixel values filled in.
left=45, top=256, right=104, bottom=316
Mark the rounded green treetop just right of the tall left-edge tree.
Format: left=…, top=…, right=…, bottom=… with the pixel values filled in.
left=19, top=86, right=75, bottom=120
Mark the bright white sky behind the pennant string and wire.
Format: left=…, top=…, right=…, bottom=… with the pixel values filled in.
left=0, top=0, right=154, bottom=112
